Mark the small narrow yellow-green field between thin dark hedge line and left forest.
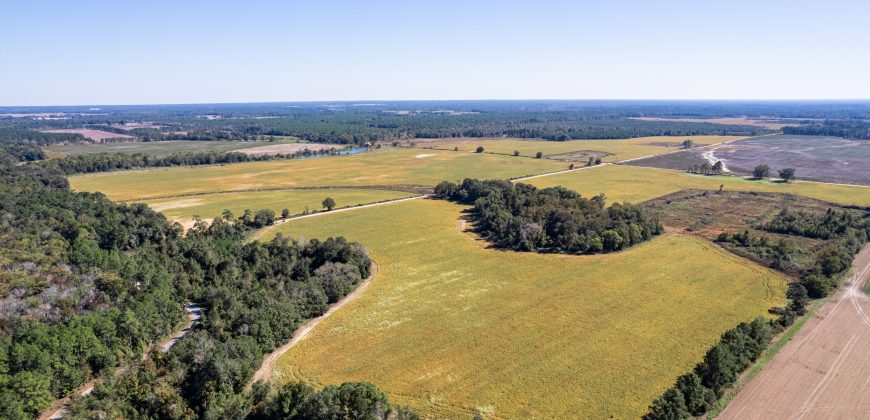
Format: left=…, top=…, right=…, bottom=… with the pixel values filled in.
left=144, top=189, right=413, bottom=223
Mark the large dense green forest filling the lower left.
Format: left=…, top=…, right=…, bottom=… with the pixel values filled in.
left=0, top=145, right=405, bottom=418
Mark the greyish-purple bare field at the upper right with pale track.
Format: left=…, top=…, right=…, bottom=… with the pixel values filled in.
left=631, top=135, right=870, bottom=185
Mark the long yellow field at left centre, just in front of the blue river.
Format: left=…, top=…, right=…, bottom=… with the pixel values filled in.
left=69, top=149, right=567, bottom=200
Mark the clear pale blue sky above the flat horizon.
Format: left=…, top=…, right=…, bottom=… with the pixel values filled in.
left=0, top=0, right=870, bottom=105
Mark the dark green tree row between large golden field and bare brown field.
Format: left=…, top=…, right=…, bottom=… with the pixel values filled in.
left=643, top=317, right=780, bottom=420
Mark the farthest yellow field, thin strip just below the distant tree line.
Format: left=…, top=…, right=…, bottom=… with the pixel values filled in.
left=416, top=136, right=743, bottom=162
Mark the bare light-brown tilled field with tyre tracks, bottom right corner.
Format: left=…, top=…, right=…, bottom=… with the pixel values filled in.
left=718, top=244, right=870, bottom=419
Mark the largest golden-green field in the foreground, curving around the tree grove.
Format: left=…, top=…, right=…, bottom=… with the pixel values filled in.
left=265, top=200, right=784, bottom=418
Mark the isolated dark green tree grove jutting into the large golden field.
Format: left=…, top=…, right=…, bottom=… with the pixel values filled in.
left=435, top=179, right=662, bottom=254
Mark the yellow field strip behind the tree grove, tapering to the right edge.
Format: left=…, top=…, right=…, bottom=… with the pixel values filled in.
left=524, top=165, right=870, bottom=206
